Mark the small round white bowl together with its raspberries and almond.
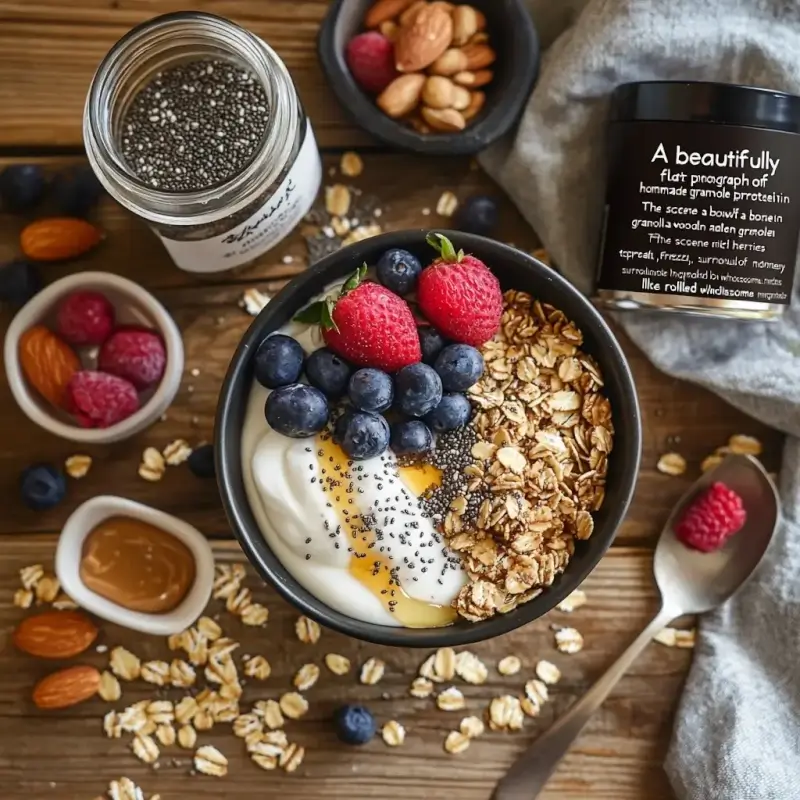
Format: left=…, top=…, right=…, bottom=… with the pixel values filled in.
left=4, top=272, right=183, bottom=444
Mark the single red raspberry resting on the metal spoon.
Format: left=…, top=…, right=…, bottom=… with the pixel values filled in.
left=675, top=482, right=747, bottom=553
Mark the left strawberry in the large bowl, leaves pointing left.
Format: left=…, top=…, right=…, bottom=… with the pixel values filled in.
left=295, top=264, right=422, bottom=372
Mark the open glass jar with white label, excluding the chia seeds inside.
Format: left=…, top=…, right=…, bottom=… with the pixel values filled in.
left=83, top=12, right=322, bottom=273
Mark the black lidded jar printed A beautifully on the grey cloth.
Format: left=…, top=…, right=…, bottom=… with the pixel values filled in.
left=596, top=81, right=800, bottom=319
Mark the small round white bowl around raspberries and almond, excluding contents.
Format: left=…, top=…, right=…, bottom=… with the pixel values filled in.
left=4, top=272, right=183, bottom=444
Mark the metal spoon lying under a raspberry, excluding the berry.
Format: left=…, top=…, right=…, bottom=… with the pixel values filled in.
left=492, top=455, right=780, bottom=800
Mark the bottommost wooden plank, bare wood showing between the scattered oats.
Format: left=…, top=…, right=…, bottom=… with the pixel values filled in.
left=0, top=537, right=691, bottom=800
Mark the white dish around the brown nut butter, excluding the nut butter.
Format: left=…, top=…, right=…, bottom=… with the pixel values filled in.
left=56, top=495, right=214, bottom=636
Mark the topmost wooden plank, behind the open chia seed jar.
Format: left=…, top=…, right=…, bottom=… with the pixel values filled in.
left=0, top=0, right=374, bottom=147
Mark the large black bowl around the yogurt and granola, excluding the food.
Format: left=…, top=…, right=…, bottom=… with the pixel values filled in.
left=216, top=230, right=641, bottom=647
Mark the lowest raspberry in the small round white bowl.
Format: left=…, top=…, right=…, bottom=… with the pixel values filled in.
left=67, top=370, right=139, bottom=428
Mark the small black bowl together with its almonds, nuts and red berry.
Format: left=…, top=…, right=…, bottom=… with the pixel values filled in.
left=318, top=0, right=539, bottom=155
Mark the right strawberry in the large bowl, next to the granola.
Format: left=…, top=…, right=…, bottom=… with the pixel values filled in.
left=417, top=233, right=503, bottom=347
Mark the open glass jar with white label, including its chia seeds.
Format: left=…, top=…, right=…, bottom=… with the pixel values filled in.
left=83, top=12, right=322, bottom=273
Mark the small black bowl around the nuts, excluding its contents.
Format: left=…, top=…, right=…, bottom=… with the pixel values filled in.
left=318, top=0, right=539, bottom=155
